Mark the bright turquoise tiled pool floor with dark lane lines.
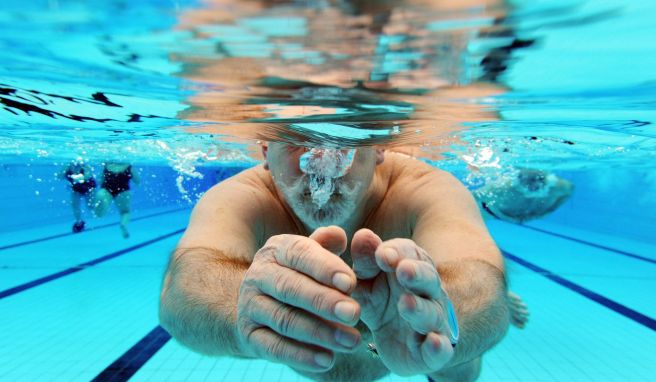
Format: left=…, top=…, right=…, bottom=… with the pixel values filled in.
left=0, top=208, right=656, bottom=382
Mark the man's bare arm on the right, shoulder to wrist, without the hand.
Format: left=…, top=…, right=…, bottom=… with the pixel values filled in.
left=413, top=173, right=509, bottom=368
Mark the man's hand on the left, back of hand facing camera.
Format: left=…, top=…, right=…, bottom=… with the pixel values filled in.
left=237, top=226, right=360, bottom=372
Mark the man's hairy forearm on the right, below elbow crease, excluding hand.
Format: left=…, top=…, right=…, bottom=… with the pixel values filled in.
left=438, top=260, right=510, bottom=369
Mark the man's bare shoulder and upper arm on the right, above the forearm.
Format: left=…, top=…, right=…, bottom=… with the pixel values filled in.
left=376, top=153, right=503, bottom=269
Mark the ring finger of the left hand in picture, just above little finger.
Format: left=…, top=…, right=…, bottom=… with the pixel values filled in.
left=249, top=295, right=360, bottom=352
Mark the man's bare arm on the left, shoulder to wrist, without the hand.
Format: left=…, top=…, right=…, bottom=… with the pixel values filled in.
left=160, top=175, right=257, bottom=355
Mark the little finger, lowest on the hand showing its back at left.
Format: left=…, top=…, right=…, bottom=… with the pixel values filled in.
left=248, top=327, right=335, bottom=371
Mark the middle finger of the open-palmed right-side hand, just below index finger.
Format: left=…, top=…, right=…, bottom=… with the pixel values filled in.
left=396, top=259, right=442, bottom=299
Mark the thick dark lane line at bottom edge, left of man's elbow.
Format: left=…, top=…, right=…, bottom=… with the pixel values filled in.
left=91, top=325, right=171, bottom=382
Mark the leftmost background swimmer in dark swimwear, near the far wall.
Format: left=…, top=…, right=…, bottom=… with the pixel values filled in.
left=58, top=157, right=96, bottom=233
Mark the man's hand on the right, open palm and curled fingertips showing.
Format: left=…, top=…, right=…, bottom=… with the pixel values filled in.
left=351, top=229, right=454, bottom=375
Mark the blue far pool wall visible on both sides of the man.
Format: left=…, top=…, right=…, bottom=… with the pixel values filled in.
left=0, top=163, right=656, bottom=244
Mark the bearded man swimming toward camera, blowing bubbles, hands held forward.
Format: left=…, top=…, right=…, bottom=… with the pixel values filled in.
left=160, top=143, right=510, bottom=381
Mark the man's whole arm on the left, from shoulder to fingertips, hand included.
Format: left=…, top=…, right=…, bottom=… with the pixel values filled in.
left=160, top=170, right=360, bottom=372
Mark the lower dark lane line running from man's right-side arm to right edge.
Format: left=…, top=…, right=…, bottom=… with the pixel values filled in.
left=501, top=250, right=656, bottom=331
